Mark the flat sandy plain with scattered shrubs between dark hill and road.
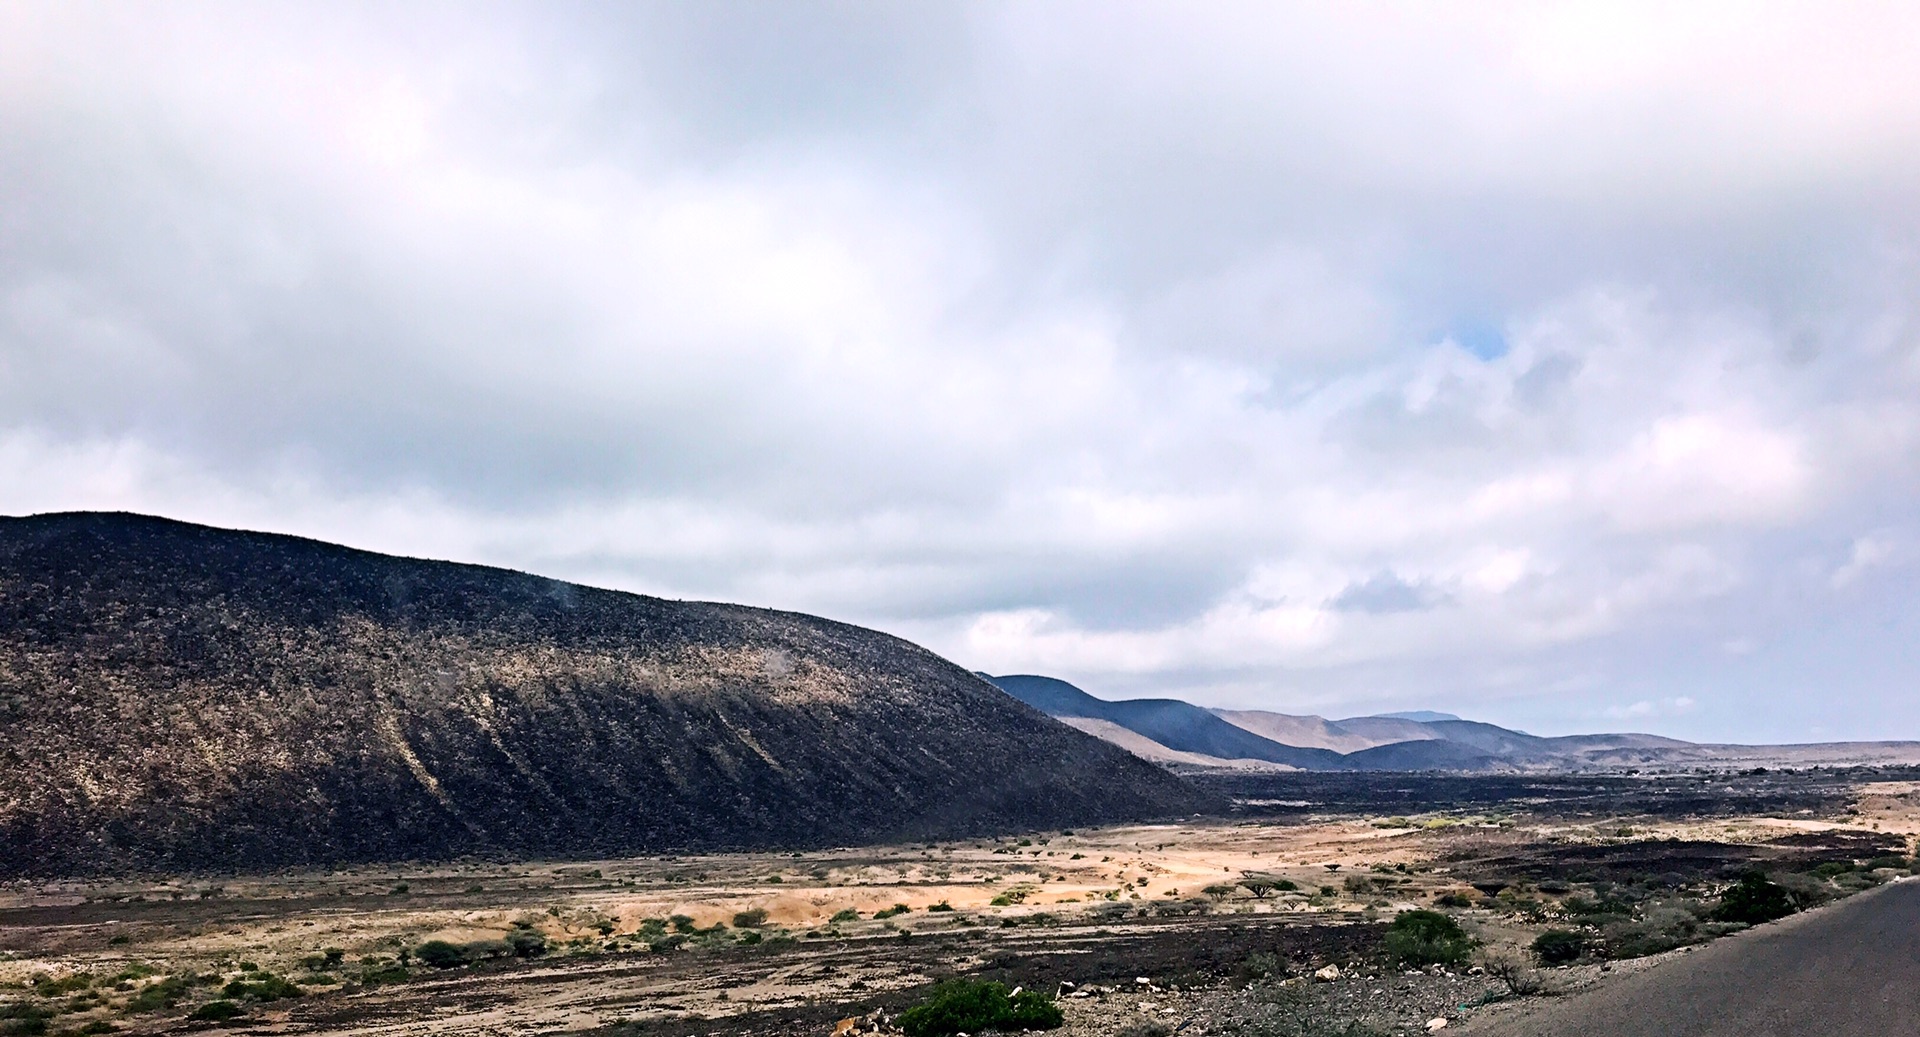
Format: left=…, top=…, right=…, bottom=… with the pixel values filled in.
left=0, top=768, right=1920, bottom=1037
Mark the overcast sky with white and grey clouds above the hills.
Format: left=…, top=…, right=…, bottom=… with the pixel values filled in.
left=0, top=0, right=1920, bottom=741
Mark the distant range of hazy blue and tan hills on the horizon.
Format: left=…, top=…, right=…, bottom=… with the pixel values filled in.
left=981, top=674, right=1920, bottom=772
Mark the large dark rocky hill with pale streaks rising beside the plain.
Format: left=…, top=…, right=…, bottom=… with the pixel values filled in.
left=0, top=513, right=1213, bottom=874
